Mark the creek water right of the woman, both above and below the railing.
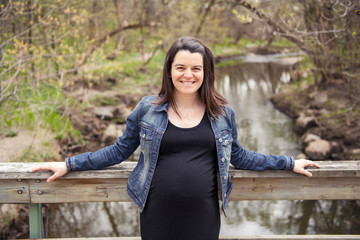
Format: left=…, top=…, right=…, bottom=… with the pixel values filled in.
left=217, top=62, right=360, bottom=236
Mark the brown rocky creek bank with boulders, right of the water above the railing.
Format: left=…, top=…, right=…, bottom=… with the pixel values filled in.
left=271, top=79, right=360, bottom=160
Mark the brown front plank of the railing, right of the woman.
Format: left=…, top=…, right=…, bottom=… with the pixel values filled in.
left=231, top=177, right=360, bottom=200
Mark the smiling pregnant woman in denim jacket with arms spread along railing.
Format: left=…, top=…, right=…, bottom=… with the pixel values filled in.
left=33, top=37, right=319, bottom=240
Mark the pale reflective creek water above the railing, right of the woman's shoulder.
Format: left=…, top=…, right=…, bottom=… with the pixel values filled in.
left=216, top=63, right=300, bottom=155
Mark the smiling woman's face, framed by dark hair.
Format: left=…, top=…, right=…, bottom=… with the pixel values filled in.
left=171, top=50, right=204, bottom=95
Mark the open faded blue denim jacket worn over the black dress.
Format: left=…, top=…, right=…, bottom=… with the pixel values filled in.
left=65, top=96, right=294, bottom=214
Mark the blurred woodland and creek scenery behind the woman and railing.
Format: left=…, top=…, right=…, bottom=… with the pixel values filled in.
left=0, top=0, right=360, bottom=239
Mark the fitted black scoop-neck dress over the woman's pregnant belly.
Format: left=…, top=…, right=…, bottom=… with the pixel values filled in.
left=140, top=114, right=220, bottom=240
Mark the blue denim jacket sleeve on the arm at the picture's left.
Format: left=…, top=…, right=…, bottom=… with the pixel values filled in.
left=65, top=99, right=142, bottom=171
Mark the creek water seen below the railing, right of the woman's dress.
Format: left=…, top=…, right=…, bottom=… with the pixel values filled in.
left=221, top=200, right=360, bottom=236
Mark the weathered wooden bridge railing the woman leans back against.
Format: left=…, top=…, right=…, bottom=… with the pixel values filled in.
left=0, top=161, right=360, bottom=240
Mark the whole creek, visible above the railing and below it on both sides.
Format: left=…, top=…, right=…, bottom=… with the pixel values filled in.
left=48, top=56, right=360, bottom=237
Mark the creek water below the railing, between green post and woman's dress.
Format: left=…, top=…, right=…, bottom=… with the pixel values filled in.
left=49, top=202, right=140, bottom=238
